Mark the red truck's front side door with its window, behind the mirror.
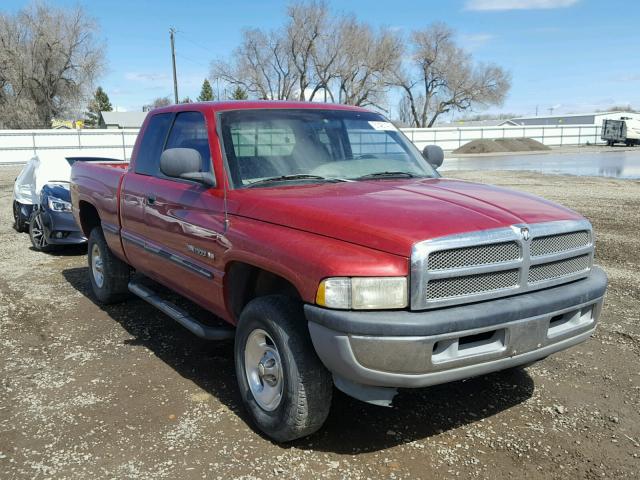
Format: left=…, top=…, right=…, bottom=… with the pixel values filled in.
left=144, top=111, right=227, bottom=314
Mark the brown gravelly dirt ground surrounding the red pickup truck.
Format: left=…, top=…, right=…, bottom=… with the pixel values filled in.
left=0, top=167, right=640, bottom=480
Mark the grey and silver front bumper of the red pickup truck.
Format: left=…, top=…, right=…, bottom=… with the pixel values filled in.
left=305, top=267, right=607, bottom=400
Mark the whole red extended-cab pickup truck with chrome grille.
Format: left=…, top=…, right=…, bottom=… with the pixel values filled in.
left=71, top=101, right=607, bottom=441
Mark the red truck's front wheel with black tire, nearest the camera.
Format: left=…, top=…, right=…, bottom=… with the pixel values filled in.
left=234, top=295, right=333, bottom=442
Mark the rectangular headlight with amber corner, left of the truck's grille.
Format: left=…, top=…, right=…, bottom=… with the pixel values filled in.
left=316, top=277, right=407, bottom=310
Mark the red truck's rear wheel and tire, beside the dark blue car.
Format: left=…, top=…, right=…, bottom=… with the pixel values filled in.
left=87, top=227, right=131, bottom=304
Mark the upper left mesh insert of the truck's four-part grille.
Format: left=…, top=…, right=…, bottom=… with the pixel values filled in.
left=427, top=242, right=520, bottom=270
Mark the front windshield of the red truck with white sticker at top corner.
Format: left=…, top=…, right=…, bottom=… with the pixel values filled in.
left=220, top=109, right=438, bottom=188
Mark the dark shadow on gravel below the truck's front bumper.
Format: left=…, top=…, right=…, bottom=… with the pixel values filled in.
left=304, top=369, right=534, bottom=455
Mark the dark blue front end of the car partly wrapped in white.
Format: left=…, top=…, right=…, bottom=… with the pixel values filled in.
left=29, top=182, right=87, bottom=252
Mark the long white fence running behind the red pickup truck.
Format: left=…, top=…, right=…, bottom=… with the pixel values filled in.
left=0, top=125, right=603, bottom=164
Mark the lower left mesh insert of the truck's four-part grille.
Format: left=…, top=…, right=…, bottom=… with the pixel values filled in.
left=427, top=269, right=519, bottom=299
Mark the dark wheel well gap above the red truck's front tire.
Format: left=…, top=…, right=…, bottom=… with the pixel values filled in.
left=225, top=262, right=302, bottom=319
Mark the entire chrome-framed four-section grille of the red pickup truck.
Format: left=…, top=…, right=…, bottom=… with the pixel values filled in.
left=410, top=220, right=593, bottom=310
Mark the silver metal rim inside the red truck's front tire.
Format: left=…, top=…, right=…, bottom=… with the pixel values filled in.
left=244, top=329, right=284, bottom=412
